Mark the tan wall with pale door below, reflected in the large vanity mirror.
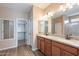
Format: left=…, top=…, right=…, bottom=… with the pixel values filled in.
left=55, top=16, right=63, bottom=35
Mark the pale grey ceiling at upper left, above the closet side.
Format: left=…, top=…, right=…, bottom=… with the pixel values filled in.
left=0, top=3, right=32, bottom=13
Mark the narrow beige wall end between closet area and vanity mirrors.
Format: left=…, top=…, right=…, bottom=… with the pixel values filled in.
left=32, top=6, right=43, bottom=50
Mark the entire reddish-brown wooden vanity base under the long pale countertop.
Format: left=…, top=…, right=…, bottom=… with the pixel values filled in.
left=37, top=36, right=79, bottom=56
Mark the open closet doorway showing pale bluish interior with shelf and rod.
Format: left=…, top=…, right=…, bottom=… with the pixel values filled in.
left=17, top=20, right=27, bottom=46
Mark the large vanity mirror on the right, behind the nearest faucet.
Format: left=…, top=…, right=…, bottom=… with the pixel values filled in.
left=51, top=5, right=79, bottom=36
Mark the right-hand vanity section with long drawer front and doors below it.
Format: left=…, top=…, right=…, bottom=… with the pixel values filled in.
left=52, top=41, right=77, bottom=56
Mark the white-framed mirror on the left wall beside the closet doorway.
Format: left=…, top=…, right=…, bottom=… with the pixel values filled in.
left=0, top=19, right=14, bottom=39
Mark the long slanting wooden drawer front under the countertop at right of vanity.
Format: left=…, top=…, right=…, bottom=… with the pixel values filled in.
left=52, top=41, right=77, bottom=55
